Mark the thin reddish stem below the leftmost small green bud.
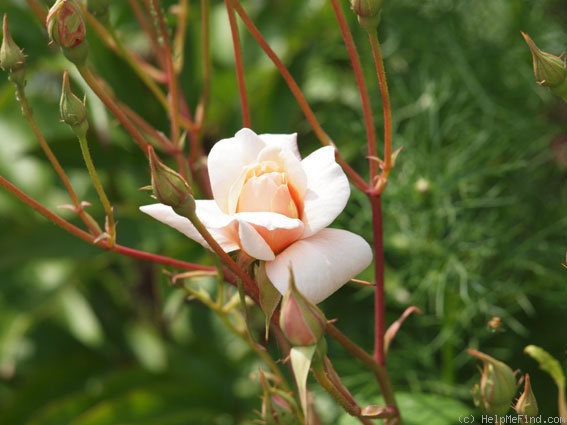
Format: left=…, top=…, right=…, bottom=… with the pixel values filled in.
left=15, top=84, right=99, bottom=235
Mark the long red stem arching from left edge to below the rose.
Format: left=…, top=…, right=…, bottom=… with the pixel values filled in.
left=0, top=176, right=216, bottom=272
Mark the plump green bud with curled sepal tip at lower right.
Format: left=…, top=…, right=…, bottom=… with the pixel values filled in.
left=467, top=350, right=518, bottom=416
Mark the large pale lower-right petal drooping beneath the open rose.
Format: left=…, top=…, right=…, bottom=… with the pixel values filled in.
left=266, top=229, right=372, bottom=304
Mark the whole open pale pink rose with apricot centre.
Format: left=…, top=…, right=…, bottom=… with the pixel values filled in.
left=140, top=128, right=372, bottom=303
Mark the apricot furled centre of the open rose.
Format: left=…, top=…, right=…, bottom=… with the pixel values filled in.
left=236, top=161, right=301, bottom=218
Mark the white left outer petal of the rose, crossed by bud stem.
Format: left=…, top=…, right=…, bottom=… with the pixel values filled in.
left=140, top=200, right=240, bottom=252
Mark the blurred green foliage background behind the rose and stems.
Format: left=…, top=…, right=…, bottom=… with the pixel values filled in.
left=0, top=0, right=567, bottom=425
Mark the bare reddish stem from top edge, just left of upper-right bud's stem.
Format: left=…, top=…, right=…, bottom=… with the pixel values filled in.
left=331, top=0, right=378, bottom=184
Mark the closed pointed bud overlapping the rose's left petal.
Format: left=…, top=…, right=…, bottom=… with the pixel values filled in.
left=148, top=146, right=195, bottom=217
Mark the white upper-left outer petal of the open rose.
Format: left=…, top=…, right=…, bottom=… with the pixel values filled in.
left=207, top=128, right=266, bottom=214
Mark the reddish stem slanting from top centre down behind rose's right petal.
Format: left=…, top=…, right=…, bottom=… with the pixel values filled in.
left=228, top=0, right=369, bottom=193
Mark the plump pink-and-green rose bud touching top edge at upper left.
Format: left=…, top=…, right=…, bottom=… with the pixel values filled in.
left=45, top=0, right=88, bottom=64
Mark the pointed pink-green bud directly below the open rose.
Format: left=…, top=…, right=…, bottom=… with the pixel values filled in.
left=280, top=270, right=327, bottom=346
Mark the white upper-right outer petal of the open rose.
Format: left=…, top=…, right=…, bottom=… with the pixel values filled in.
left=301, top=146, right=350, bottom=238
